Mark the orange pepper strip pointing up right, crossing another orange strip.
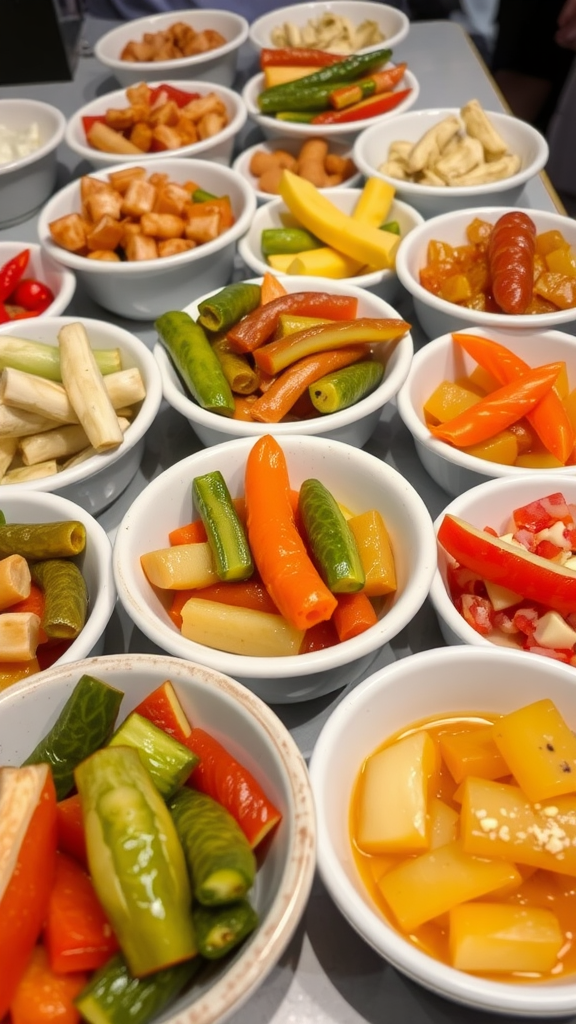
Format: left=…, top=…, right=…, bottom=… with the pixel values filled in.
left=428, top=362, right=563, bottom=447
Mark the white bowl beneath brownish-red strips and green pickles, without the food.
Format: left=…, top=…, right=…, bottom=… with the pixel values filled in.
left=154, top=276, right=414, bottom=447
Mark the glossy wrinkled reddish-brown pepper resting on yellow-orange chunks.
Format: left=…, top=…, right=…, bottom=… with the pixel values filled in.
left=488, top=210, right=536, bottom=315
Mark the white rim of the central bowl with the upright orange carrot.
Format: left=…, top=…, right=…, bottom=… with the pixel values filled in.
left=113, top=431, right=436, bottom=680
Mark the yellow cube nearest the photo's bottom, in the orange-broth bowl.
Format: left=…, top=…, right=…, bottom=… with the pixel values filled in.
left=449, top=903, right=564, bottom=974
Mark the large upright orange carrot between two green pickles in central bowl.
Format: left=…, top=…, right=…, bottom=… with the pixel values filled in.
left=245, top=434, right=337, bottom=630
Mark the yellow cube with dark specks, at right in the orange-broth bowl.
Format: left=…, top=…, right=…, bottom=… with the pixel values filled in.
left=493, top=698, right=576, bottom=803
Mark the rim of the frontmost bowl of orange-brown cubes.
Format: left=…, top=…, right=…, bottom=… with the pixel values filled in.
left=37, top=157, right=256, bottom=278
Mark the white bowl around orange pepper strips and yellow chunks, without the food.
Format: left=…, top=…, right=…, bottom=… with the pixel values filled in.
left=398, top=328, right=576, bottom=495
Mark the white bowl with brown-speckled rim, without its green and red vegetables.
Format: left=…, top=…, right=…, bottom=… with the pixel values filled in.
left=0, top=654, right=316, bottom=1024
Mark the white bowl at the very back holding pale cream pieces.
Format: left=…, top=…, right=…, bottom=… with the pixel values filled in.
left=249, top=0, right=410, bottom=53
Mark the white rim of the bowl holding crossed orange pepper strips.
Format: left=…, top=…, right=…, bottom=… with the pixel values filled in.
left=397, top=325, right=576, bottom=480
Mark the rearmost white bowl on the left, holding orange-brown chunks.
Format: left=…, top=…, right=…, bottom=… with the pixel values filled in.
left=94, top=7, right=248, bottom=86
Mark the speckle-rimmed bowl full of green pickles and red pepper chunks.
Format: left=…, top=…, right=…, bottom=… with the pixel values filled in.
left=0, top=654, right=316, bottom=1024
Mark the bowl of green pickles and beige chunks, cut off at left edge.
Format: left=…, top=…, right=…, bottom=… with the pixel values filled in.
left=0, top=486, right=116, bottom=690
